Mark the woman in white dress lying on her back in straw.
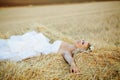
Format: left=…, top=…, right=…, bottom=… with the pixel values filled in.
left=0, top=31, right=90, bottom=73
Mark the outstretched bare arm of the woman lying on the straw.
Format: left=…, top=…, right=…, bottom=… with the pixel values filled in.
left=62, top=51, right=79, bottom=73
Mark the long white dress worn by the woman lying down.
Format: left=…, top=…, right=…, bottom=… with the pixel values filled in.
left=0, top=31, right=62, bottom=61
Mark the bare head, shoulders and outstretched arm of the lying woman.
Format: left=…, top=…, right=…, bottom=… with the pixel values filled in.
left=58, top=40, right=90, bottom=73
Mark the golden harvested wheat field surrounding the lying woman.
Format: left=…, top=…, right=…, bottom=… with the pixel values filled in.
left=0, top=1, right=120, bottom=80
